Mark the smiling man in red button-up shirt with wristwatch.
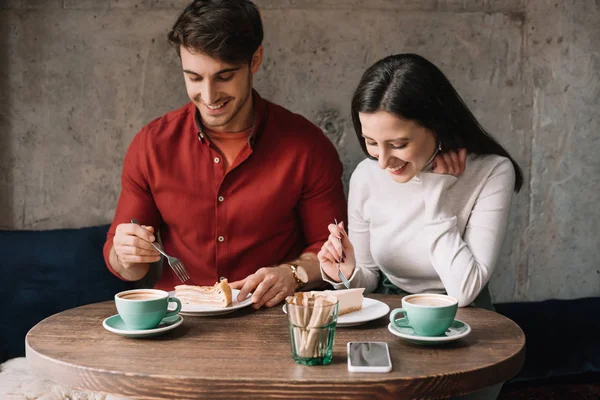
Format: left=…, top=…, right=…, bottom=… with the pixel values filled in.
left=104, top=0, right=346, bottom=308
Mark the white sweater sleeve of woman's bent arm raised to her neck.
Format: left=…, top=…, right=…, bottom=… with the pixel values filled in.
left=421, top=159, right=515, bottom=307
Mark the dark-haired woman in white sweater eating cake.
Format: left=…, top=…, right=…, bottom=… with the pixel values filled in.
left=318, top=54, right=523, bottom=309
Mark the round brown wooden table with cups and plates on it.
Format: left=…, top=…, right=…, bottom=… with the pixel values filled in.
left=26, top=295, right=525, bottom=399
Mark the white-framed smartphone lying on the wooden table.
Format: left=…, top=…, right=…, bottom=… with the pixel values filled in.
left=348, top=342, right=392, bottom=372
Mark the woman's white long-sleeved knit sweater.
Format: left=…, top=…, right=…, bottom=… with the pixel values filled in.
left=321, top=155, right=515, bottom=306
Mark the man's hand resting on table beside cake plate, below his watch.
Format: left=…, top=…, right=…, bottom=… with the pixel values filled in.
left=229, top=264, right=297, bottom=309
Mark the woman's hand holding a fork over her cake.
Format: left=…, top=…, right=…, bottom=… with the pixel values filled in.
left=317, top=221, right=356, bottom=282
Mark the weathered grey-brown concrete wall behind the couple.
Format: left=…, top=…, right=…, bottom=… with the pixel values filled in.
left=0, top=0, right=600, bottom=302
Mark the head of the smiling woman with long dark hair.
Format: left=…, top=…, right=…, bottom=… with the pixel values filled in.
left=352, top=54, right=523, bottom=191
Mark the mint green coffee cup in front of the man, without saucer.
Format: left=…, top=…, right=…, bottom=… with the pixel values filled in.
left=115, top=289, right=181, bottom=330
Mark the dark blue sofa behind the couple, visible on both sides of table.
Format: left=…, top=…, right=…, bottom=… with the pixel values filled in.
left=0, top=225, right=600, bottom=382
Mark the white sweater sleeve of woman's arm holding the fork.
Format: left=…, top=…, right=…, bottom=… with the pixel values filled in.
left=321, top=166, right=379, bottom=293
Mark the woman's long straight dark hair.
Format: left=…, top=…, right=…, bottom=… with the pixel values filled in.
left=352, top=54, right=523, bottom=192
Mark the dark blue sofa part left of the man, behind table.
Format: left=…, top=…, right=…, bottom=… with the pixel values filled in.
left=0, top=225, right=131, bottom=361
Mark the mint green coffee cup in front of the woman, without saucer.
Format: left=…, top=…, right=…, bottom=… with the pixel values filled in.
left=390, top=293, right=458, bottom=336
